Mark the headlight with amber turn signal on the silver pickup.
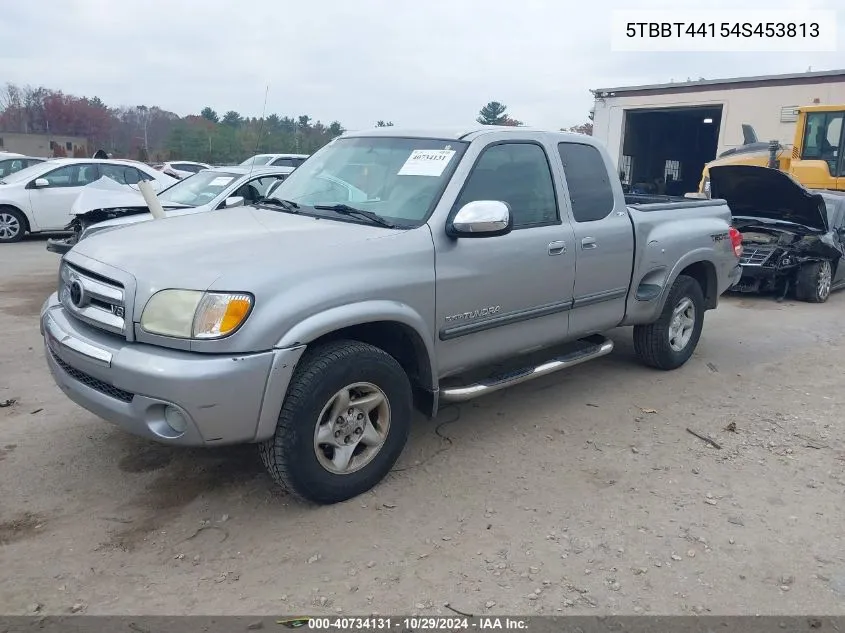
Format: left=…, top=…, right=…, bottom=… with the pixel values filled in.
left=141, top=289, right=252, bottom=339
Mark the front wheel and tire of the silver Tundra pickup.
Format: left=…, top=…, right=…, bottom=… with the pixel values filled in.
left=259, top=341, right=413, bottom=504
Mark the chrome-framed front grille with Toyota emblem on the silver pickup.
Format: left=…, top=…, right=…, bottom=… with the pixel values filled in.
left=59, top=263, right=126, bottom=336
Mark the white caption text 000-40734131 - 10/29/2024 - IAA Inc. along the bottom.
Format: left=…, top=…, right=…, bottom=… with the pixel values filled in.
left=308, top=616, right=528, bottom=631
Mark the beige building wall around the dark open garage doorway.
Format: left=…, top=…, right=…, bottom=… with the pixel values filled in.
left=593, top=80, right=845, bottom=165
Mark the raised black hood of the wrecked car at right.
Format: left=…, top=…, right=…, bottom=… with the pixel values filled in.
left=709, top=165, right=829, bottom=232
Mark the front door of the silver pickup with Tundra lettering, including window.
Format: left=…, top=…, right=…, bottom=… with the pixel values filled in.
left=435, top=139, right=575, bottom=375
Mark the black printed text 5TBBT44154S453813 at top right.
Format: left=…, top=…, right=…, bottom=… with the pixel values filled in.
left=625, top=22, right=820, bottom=39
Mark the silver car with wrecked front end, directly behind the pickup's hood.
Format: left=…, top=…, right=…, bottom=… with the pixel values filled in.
left=47, top=166, right=294, bottom=254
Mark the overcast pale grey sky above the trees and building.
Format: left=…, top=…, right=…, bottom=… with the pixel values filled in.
left=0, top=0, right=845, bottom=130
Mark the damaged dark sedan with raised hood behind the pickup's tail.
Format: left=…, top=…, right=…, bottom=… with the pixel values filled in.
left=710, top=165, right=845, bottom=303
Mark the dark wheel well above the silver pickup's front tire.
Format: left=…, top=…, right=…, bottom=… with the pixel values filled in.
left=308, top=321, right=436, bottom=415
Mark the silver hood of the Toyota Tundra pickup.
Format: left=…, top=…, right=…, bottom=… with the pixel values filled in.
left=68, top=207, right=402, bottom=299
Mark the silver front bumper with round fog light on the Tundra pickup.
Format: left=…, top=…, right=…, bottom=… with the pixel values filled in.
left=41, top=293, right=305, bottom=446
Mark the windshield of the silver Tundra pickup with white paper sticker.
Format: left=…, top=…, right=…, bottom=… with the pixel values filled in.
left=270, top=137, right=467, bottom=226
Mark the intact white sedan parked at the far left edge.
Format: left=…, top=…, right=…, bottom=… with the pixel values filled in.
left=0, top=158, right=179, bottom=244
